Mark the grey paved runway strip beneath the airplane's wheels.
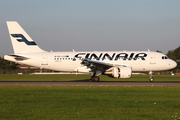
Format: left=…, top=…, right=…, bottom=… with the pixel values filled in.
left=0, top=81, right=180, bottom=86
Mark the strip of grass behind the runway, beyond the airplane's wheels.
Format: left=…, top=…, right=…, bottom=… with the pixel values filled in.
left=0, top=74, right=180, bottom=82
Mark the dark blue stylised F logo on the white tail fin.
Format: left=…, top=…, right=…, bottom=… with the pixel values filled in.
left=11, top=34, right=36, bottom=45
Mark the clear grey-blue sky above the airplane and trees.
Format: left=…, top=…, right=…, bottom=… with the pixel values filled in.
left=0, top=0, right=180, bottom=57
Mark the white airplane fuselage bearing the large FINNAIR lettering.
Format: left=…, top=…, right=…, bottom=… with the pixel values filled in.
left=4, top=51, right=177, bottom=72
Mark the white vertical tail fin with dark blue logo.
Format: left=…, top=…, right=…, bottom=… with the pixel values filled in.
left=7, top=21, right=45, bottom=53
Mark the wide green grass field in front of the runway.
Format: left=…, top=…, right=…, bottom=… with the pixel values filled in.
left=0, top=86, right=180, bottom=120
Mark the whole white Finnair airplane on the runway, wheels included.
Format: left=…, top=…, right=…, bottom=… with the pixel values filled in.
left=4, top=21, right=177, bottom=82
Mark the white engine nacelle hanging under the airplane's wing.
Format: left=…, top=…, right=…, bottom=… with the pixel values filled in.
left=112, top=67, right=132, bottom=78
